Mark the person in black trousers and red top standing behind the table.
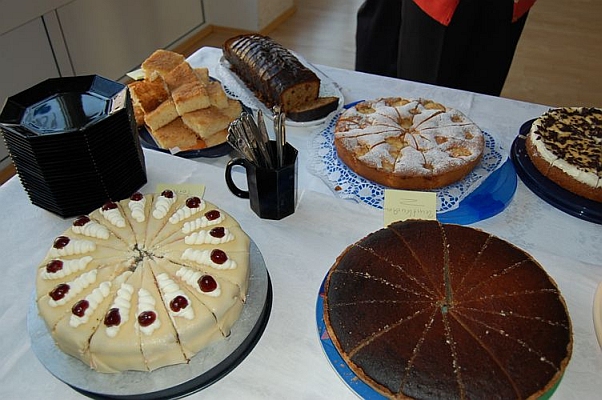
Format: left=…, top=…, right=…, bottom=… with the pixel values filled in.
left=355, top=0, right=536, bottom=96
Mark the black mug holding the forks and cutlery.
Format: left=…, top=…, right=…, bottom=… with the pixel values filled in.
left=226, top=141, right=297, bottom=219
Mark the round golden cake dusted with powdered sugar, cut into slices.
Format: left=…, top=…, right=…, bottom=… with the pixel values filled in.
left=334, top=97, right=485, bottom=189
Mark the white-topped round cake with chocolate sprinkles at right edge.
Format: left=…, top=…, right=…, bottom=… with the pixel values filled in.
left=526, top=107, right=602, bottom=202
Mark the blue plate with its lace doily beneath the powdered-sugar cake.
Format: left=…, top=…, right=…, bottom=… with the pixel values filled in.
left=310, top=108, right=517, bottom=224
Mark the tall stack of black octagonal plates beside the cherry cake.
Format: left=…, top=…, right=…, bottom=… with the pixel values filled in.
left=0, top=75, right=146, bottom=217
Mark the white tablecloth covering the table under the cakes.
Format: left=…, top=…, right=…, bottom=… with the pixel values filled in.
left=0, top=48, right=602, bottom=399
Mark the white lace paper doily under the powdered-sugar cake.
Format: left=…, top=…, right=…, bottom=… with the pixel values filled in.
left=309, top=112, right=508, bottom=213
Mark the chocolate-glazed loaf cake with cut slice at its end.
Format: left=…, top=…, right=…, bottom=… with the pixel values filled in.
left=222, top=34, right=339, bottom=121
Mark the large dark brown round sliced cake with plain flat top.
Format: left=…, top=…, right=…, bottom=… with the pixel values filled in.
left=324, top=220, right=573, bottom=399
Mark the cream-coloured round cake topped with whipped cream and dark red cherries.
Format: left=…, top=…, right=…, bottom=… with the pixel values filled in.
left=36, top=190, right=250, bottom=373
